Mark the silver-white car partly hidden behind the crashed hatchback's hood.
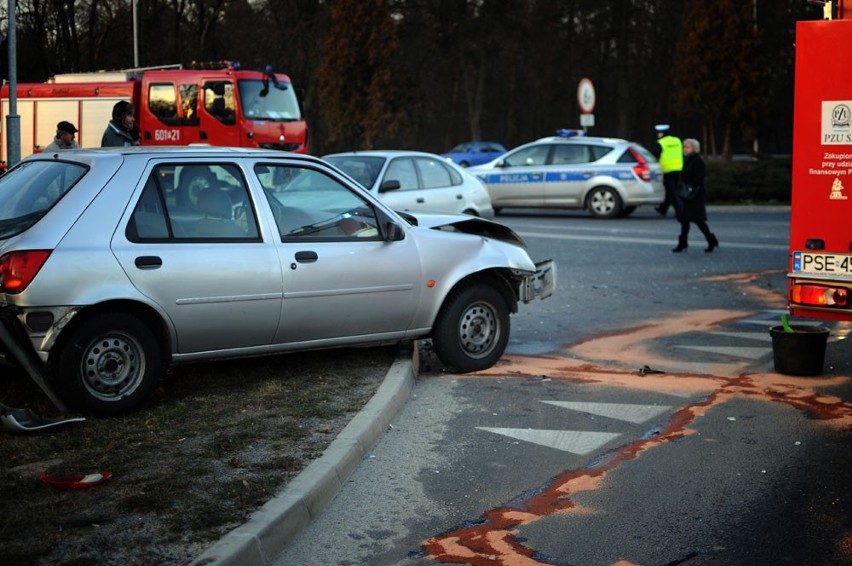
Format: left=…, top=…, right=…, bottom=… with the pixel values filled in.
left=323, top=150, right=494, bottom=220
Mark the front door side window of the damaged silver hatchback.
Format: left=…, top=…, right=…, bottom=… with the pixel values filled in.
left=255, top=164, right=381, bottom=242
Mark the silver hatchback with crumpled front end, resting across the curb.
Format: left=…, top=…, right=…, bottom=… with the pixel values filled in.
left=0, top=147, right=556, bottom=415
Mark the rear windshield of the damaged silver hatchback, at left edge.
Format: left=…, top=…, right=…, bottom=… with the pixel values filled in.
left=0, top=160, right=87, bottom=238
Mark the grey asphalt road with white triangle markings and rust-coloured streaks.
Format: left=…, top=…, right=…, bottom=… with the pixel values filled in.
left=275, top=208, right=852, bottom=566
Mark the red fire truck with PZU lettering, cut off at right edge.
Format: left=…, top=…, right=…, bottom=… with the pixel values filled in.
left=787, top=0, right=852, bottom=320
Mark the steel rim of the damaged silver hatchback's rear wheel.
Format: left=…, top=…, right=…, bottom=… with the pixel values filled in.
left=80, top=334, right=145, bottom=400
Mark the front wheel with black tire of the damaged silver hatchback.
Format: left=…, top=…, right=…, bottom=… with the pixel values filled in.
left=432, top=284, right=511, bottom=373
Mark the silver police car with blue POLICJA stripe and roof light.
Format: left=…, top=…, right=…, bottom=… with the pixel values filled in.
left=468, top=130, right=665, bottom=218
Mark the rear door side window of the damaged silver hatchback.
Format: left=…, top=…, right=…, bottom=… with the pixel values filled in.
left=126, top=164, right=261, bottom=242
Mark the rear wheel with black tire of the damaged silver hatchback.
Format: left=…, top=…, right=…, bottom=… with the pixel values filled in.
left=52, top=313, right=162, bottom=416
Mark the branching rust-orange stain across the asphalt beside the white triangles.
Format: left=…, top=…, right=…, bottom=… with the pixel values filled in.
left=424, top=310, right=852, bottom=566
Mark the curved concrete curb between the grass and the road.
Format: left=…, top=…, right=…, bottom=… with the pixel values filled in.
left=191, top=344, right=419, bottom=566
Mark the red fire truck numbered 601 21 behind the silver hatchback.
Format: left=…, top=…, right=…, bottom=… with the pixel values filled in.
left=0, top=63, right=308, bottom=162
